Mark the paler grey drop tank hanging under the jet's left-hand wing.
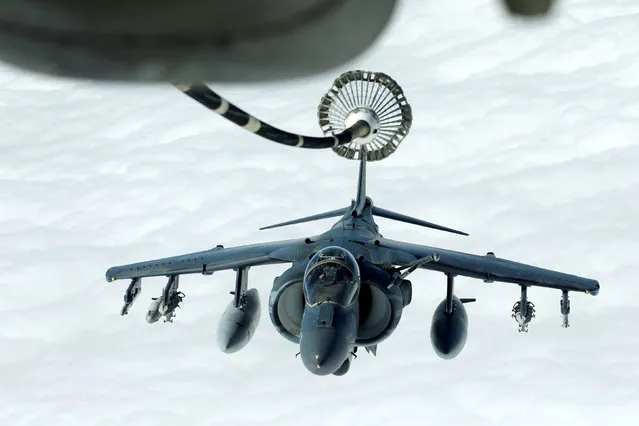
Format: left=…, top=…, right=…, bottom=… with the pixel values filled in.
left=217, top=288, right=261, bottom=354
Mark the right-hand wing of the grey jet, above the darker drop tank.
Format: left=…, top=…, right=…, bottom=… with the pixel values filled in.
left=375, top=238, right=599, bottom=295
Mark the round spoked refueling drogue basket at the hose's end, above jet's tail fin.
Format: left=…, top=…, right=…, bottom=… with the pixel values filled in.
left=317, top=71, right=413, bottom=161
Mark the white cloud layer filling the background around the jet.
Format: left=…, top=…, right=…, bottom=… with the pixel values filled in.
left=0, top=0, right=639, bottom=426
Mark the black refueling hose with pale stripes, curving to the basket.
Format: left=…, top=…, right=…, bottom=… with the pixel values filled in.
left=173, top=83, right=371, bottom=149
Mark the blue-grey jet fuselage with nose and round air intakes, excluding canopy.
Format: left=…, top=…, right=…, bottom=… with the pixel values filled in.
left=269, top=198, right=412, bottom=375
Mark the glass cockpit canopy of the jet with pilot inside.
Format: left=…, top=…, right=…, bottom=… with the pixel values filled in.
left=304, top=247, right=360, bottom=306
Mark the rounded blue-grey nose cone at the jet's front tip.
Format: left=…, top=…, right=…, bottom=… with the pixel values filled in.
left=300, top=329, right=348, bottom=376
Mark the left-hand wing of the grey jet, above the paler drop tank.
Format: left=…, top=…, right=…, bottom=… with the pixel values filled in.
left=106, top=239, right=312, bottom=282
